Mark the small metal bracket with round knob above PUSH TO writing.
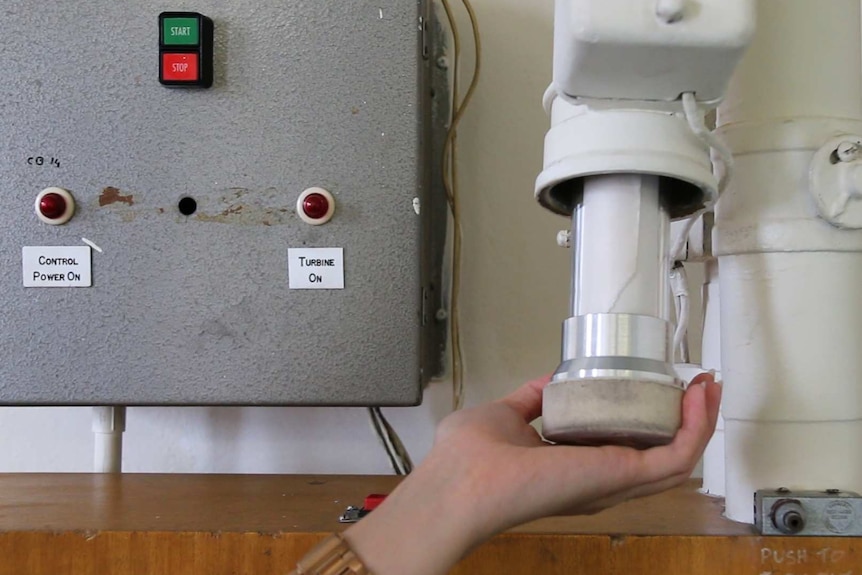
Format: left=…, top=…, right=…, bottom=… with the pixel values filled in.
left=754, top=488, right=862, bottom=537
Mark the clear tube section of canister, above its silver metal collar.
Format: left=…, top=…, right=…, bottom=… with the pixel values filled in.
left=571, top=174, right=670, bottom=320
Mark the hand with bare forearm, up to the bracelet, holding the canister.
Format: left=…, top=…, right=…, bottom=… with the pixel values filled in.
left=345, top=374, right=721, bottom=575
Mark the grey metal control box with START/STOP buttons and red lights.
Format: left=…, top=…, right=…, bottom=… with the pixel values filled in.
left=0, top=0, right=445, bottom=406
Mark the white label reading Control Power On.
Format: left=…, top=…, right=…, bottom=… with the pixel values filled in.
left=21, top=246, right=93, bottom=287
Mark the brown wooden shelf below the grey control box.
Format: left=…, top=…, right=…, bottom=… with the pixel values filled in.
left=0, top=474, right=862, bottom=575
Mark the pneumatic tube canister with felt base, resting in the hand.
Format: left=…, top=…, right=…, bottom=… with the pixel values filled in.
left=543, top=174, right=682, bottom=447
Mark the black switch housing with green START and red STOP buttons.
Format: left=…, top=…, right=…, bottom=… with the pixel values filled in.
left=159, top=12, right=215, bottom=88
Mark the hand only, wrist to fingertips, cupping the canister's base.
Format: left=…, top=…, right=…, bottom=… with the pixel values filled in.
left=432, top=374, right=721, bottom=536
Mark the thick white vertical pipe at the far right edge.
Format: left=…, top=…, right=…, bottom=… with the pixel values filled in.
left=714, top=0, right=862, bottom=523
